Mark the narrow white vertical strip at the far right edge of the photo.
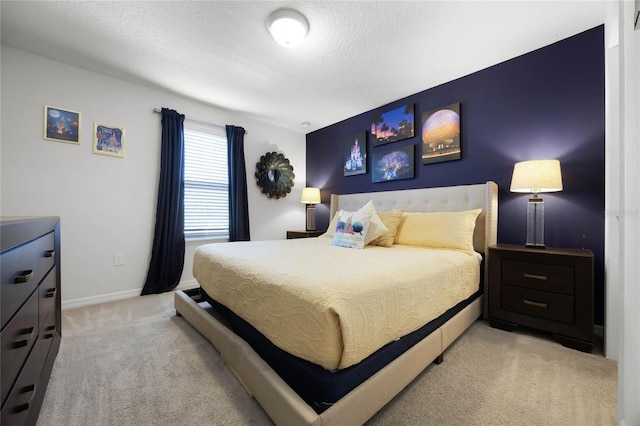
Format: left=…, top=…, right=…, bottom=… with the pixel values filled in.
left=612, top=1, right=640, bottom=426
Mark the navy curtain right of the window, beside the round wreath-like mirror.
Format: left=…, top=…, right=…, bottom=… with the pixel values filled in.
left=225, top=126, right=251, bottom=241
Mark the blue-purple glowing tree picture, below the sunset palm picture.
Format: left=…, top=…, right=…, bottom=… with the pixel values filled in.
left=371, top=144, right=415, bottom=183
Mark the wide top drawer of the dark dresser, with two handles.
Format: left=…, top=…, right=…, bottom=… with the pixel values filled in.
left=0, top=232, right=55, bottom=328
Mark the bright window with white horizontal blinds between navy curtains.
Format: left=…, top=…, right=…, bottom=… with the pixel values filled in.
left=184, top=120, right=229, bottom=239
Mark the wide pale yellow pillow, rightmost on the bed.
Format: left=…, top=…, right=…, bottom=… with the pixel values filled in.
left=396, top=209, right=482, bottom=251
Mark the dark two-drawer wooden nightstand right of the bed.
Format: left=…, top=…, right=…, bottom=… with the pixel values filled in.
left=489, top=244, right=593, bottom=352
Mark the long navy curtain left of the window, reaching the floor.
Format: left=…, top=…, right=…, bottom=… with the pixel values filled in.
left=142, top=108, right=184, bottom=295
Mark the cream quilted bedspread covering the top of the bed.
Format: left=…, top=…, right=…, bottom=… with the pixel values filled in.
left=193, top=238, right=480, bottom=370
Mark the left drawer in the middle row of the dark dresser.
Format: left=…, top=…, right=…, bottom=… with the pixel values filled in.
left=0, top=293, right=39, bottom=401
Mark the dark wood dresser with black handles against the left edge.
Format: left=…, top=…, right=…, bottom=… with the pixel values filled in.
left=0, top=217, right=61, bottom=426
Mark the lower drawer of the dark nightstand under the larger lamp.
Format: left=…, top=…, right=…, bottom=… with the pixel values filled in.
left=502, top=285, right=575, bottom=324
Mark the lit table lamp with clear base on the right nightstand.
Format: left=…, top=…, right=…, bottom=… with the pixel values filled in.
left=511, top=160, right=562, bottom=248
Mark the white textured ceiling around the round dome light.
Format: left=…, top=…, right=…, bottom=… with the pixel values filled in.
left=0, top=0, right=606, bottom=133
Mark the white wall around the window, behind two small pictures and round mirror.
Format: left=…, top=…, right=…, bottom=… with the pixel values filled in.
left=0, top=46, right=306, bottom=307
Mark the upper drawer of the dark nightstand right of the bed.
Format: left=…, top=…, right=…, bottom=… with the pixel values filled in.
left=502, top=260, right=574, bottom=295
